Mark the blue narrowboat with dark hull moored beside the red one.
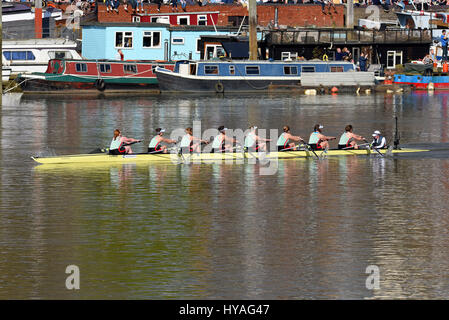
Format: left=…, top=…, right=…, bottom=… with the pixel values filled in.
left=155, top=60, right=356, bottom=93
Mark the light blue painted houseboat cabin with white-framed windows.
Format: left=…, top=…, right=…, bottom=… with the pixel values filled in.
left=82, top=23, right=245, bottom=60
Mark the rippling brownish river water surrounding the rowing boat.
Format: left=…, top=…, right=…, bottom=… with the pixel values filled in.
left=0, top=93, right=449, bottom=299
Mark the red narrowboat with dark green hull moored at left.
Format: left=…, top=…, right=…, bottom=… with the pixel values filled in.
left=16, top=59, right=174, bottom=93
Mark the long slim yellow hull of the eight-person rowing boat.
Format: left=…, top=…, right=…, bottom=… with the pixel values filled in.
left=32, top=149, right=428, bottom=164
